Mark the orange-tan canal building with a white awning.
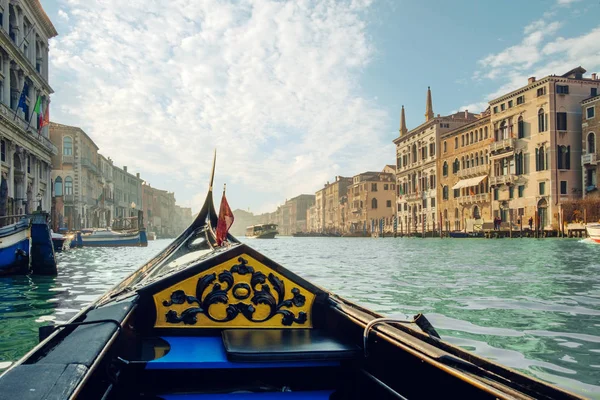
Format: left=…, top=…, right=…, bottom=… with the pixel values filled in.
left=437, top=109, right=492, bottom=232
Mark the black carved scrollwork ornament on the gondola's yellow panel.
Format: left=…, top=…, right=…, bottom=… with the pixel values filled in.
left=163, top=257, right=308, bottom=326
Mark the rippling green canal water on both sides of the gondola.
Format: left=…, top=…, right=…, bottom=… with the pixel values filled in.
left=0, top=237, right=600, bottom=398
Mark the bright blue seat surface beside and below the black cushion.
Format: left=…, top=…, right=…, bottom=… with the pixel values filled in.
left=146, top=336, right=339, bottom=369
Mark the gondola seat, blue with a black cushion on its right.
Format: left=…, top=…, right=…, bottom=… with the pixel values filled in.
left=146, top=329, right=359, bottom=370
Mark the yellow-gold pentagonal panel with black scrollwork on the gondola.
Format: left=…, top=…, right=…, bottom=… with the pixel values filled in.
left=154, top=254, right=315, bottom=328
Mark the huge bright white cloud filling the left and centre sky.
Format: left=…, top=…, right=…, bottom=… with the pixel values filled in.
left=51, top=0, right=394, bottom=212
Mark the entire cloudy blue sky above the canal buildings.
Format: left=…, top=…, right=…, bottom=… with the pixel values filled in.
left=41, top=0, right=600, bottom=213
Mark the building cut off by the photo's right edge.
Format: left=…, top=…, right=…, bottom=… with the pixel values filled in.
left=581, top=90, right=600, bottom=197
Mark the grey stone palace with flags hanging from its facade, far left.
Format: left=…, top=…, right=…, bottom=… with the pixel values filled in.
left=0, top=0, right=57, bottom=225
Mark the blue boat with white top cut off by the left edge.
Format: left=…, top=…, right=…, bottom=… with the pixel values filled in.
left=0, top=218, right=31, bottom=275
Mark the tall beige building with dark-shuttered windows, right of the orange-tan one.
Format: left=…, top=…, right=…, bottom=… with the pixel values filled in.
left=489, top=67, right=600, bottom=230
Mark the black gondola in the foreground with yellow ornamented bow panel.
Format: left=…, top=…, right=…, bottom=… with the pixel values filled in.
left=0, top=158, right=579, bottom=400
